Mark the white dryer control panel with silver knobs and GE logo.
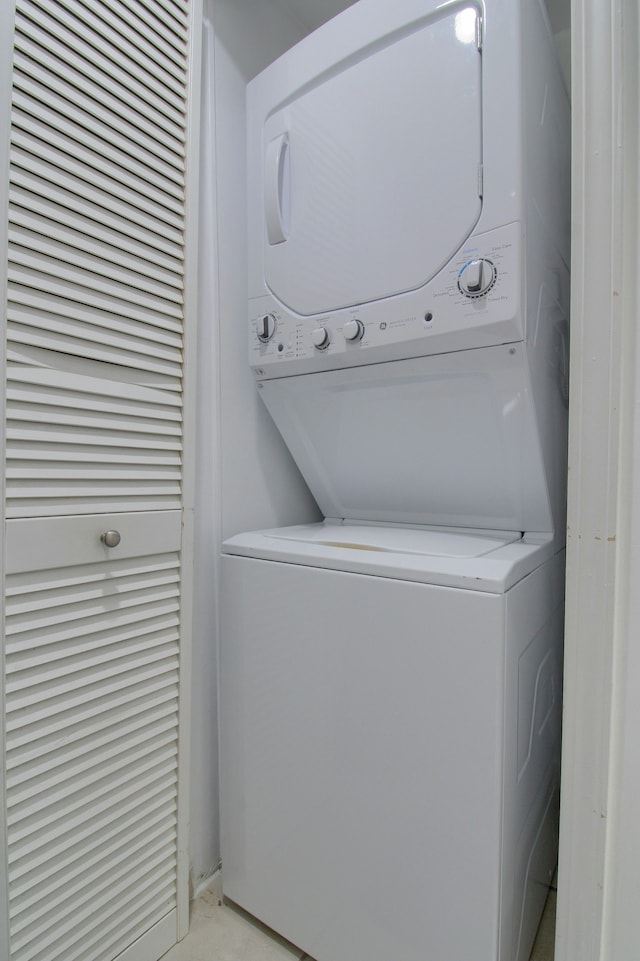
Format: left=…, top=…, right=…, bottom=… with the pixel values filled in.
left=249, top=223, right=525, bottom=380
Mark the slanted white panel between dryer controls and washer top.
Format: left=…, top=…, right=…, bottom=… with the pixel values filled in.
left=259, top=346, right=552, bottom=532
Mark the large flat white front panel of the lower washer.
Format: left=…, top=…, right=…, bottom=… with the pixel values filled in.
left=221, top=556, right=504, bottom=961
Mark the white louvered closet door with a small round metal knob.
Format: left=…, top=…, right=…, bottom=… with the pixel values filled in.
left=0, top=0, right=200, bottom=961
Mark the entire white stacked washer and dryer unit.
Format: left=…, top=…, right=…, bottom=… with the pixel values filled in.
left=221, top=0, right=569, bottom=961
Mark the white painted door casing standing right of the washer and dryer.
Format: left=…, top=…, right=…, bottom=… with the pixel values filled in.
left=556, top=0, right=628, bottom=961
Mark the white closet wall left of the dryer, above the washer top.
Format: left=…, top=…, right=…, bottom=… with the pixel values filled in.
left=213, top=0, right=318, bottom=538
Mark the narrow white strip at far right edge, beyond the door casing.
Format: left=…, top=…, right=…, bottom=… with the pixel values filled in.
left=602, top=3, right=640, bottom=961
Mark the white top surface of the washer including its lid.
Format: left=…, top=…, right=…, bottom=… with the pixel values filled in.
left=223, top=520, right=554, bottom=594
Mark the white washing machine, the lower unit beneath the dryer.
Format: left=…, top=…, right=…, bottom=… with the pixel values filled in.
left=221, top=523, right=563, bottom=961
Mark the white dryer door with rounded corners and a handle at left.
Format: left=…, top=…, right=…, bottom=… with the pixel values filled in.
left=263, top=5, right=482, bottom=316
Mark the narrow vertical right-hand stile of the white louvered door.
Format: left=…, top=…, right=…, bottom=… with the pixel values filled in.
left=177, top=0, right=202, bottom=940
